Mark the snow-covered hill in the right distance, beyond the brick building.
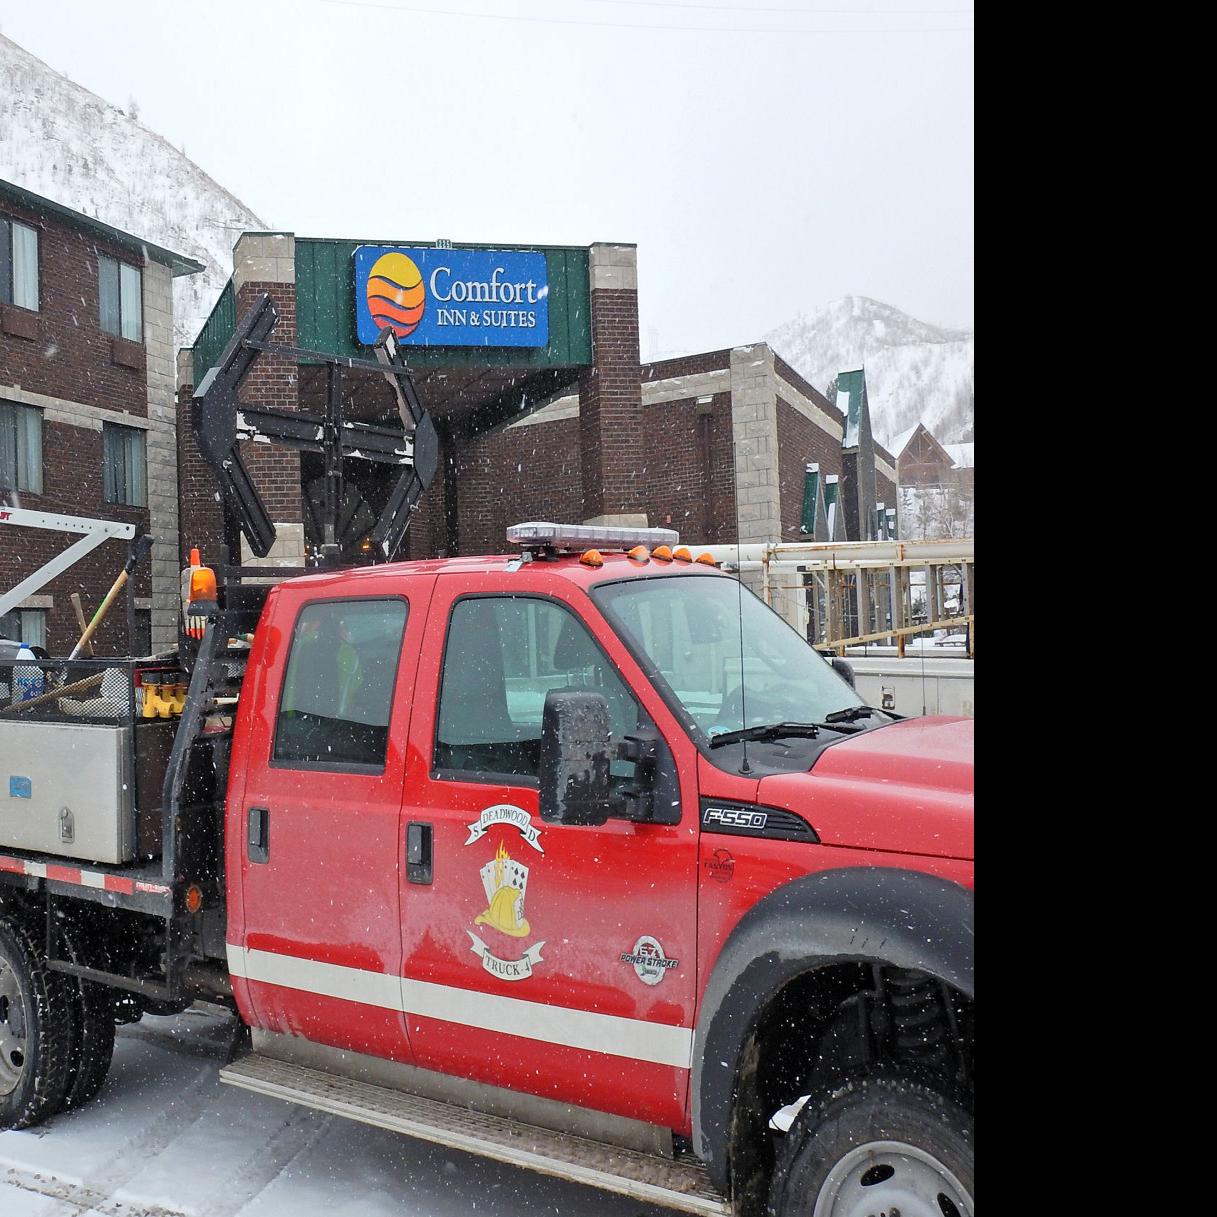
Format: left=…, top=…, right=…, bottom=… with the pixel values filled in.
left=765, top=296, right=976, bottom=444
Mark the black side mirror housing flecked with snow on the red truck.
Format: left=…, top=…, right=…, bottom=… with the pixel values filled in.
left=540, top=689, right=612, bottom=825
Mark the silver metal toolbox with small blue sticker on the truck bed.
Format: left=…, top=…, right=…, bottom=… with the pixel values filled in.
left=0, top=720, right=136, bottom=863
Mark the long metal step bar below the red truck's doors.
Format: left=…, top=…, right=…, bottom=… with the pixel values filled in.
left=220, top=1053, right=731, bottom=1217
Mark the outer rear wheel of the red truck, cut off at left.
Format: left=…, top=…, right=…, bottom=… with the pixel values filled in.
left=0, top=918, right=73, bottom=1129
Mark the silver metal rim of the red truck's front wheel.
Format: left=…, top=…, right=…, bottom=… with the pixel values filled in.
left=814, top=1142, right=974, bottom=1217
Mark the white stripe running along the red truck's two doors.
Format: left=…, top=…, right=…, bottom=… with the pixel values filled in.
left=228, top=943, right=692, bottom=1069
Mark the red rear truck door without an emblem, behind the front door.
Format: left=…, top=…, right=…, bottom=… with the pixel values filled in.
left=226, top=576, right=433, bottom=1060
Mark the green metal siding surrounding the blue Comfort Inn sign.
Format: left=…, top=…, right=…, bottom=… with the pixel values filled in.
left=299, top=237, right=591, bottom=371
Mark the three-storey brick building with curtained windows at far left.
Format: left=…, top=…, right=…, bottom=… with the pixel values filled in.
left=0, top=181, right=202, bottom=655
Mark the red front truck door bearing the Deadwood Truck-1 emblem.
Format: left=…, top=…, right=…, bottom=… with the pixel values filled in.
left=402, top=571, right=697, bottom=1128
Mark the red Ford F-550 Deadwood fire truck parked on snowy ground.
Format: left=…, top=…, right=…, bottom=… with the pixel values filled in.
left=0, top=525, right=974, bottom=1217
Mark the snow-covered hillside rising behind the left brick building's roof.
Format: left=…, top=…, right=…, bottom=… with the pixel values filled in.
left=0, top=35, right=267, bottom=346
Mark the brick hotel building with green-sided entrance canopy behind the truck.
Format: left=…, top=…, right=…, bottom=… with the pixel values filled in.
left=178, top=232, right=896, bottom=563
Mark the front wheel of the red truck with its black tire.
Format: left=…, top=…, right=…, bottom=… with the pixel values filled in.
left=769, top=1077, right=975, bottom=1217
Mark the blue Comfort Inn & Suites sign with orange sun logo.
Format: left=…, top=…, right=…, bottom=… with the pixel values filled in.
left=355, top=245, right=549, bottom=347
